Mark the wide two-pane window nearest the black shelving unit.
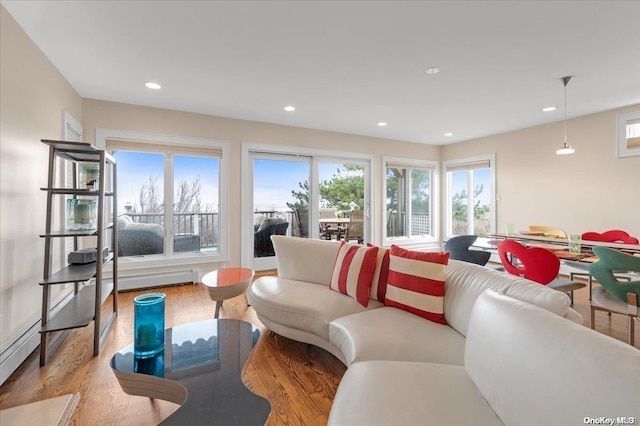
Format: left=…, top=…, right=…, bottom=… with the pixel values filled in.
left=97, top=129, right=228, bottom=266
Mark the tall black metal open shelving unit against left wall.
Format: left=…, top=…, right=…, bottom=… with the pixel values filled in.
left=40, top=139, right=118, bottom=366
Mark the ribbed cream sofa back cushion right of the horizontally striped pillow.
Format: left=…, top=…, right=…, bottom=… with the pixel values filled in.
left=444, top=260, right=571, bottom=336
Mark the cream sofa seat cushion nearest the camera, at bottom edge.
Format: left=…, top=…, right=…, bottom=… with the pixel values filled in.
left=328, top=362, right=503, bottom=426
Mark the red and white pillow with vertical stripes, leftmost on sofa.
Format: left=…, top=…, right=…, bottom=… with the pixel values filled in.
left=329, top=241, right=378, bottom=308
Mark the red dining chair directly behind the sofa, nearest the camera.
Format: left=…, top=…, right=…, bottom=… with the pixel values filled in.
left=498, top=239, right=586, bottom=305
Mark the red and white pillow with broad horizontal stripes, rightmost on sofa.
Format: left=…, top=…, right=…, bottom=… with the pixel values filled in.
left=384, top=245, right=449, bottom=324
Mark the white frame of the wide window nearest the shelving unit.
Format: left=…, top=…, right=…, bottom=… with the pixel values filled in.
left=96, top=129, right=229, bottom=270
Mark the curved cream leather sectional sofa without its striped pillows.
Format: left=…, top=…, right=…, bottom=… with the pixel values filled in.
left=249, top=236, right=640, bottom=426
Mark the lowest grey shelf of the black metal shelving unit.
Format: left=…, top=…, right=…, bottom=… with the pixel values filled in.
left=40, top=286, right=96, bottom=333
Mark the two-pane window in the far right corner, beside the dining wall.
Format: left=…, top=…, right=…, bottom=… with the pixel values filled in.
left=444, top=155, right=495, bottom=237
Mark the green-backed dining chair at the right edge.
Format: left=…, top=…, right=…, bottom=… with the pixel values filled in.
left=589, top=247, right=640, bottom=346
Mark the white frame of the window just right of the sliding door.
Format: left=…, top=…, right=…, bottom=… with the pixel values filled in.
left=381, top=156, right=440, bottom=246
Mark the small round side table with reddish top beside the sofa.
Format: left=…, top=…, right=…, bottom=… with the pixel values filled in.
left=202, top=268, right=254, bottom=318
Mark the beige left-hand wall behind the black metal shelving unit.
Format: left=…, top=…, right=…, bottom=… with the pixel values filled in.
left=0, top=6, right=82, bottom=382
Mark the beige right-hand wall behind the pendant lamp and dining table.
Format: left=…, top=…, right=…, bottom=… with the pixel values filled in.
left=442, top=104, right=640, bottom=236
